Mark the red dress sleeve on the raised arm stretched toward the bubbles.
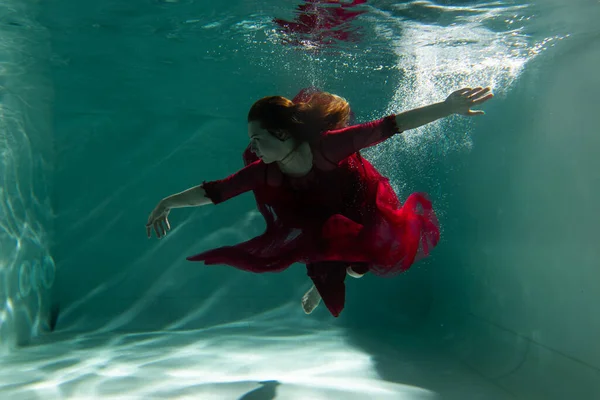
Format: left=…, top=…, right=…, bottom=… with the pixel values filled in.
left=320, top=115, right=400, bottom=164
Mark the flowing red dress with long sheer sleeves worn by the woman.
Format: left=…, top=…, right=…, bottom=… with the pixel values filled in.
left=187, top=94, right=439, bottom=317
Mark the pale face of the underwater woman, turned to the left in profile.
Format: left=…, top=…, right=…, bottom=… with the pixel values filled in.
left=248, top=121, right=294, bottom=164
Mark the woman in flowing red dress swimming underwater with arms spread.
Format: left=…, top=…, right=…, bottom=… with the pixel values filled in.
left=146, top=87, right=493, bottom=317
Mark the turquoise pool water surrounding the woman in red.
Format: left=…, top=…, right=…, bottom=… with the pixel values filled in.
left=0, top=0, right=600, bottom=399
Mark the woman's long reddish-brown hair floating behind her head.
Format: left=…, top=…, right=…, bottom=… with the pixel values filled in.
left=248, top=92, right=350, bottom=142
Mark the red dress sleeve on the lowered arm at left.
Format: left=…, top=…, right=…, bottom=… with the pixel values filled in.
left=202, top=160, right=267, bottom=204
